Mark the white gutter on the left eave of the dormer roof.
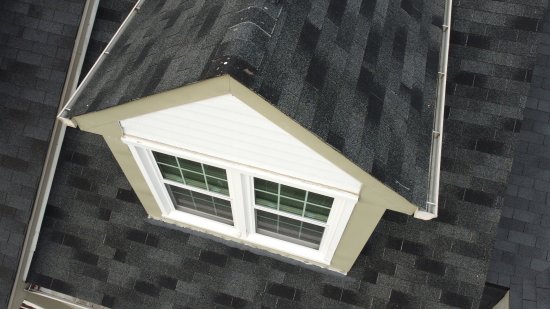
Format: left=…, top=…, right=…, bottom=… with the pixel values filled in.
left=57, top=0, right=145, bottom=128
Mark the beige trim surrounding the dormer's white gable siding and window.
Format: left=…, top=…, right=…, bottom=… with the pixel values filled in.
left=72, top=75, right=417, bottom=273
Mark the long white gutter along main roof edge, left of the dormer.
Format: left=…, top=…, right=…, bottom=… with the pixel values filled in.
left=8, top=0, right=99, bottom=308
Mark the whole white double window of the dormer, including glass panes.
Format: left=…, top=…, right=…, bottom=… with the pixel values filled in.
left=123, top=136, right=358, bottom=264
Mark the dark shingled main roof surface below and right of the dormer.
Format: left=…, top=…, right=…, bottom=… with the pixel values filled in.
left=25, top=1, right=547, bottom=308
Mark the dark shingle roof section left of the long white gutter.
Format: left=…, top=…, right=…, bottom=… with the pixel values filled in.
left=0, top=0, right=84, bottom=308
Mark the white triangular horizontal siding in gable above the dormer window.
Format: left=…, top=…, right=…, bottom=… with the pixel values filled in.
left=121, top=95, right=360, bottom=193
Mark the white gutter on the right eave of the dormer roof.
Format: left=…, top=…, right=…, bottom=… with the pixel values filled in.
left=414, top=0, right=453, bottom=220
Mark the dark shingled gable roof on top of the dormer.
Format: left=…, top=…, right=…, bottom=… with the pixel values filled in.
left=63, top=0, right=443, bottom=206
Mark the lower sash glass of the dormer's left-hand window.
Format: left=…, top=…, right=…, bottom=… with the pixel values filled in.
left=166, top=185, right=233, bottom=225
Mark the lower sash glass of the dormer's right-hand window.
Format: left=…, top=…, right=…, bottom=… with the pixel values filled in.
left=256, top=209, right=325, bottom=249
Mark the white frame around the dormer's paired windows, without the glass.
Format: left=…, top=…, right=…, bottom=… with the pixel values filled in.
left=122, top=135, right=358, bottom=265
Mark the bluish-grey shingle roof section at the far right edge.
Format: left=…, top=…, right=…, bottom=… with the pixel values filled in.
left=487, top=10, right=550, bottom=308
